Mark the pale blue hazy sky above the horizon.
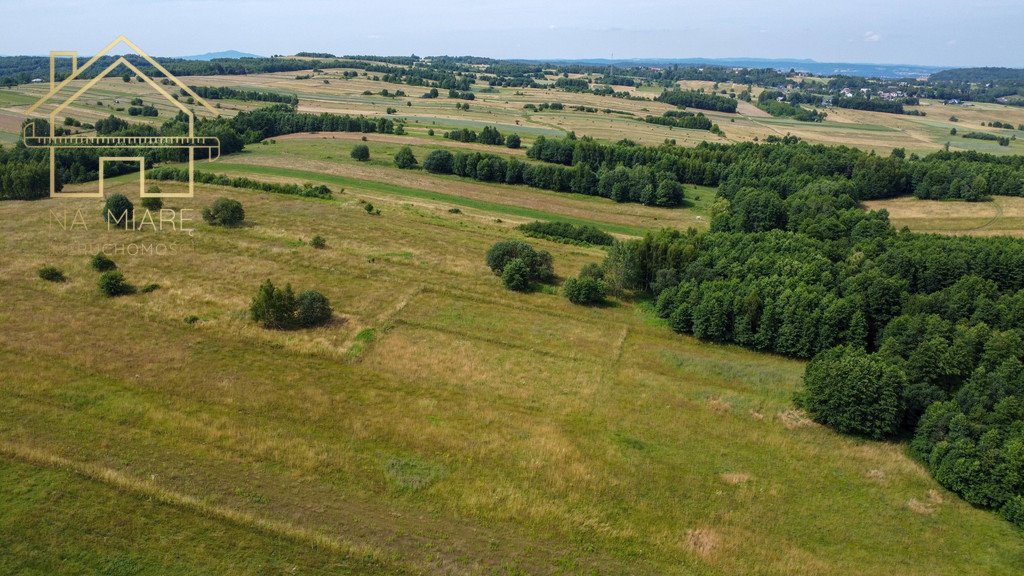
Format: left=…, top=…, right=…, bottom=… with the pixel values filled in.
left=0, top=0, right=1024, bottom=68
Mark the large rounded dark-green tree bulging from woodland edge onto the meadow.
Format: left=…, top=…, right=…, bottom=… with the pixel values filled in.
left=801, top=346, right=907, bottom=440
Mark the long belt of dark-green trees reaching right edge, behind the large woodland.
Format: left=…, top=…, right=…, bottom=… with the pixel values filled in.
left=526, top=135, right=1024, bottom=201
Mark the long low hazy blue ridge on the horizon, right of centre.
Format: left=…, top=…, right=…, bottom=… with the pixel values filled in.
left=531, top=58, right=949, bottom=78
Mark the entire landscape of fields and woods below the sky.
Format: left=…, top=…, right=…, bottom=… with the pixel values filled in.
left=0, top=32, right=1024, bottom=576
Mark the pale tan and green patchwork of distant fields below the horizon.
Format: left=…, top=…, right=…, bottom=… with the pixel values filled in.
left=0, top=59, right=1024, bottom=154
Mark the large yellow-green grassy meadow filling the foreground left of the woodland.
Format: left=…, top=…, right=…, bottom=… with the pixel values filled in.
left=0, top=144, right=1024, bottom=575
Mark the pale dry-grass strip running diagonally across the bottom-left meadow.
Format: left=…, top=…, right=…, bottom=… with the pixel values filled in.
left=0, top=441, right=404, bottom=568
